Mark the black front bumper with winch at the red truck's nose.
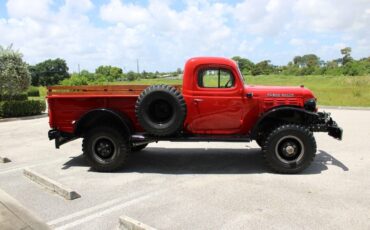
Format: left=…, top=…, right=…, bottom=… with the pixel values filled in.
left=311, top=112, right=343, bottom=140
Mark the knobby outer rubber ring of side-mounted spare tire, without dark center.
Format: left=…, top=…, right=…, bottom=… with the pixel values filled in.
left=135, top=84, right=187, bottom=136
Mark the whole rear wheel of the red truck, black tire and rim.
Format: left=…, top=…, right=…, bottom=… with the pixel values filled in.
left=82, top=126, right=130, bottom=172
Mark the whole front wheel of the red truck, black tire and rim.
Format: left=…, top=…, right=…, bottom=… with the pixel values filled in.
left=262, top=124, right=316, bottom=174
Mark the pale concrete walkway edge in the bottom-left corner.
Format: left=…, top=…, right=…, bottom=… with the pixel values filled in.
left=0, top=189, right=51, bottom=230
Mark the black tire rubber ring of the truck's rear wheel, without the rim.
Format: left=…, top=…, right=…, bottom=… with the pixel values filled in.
left=82, top=126, right=130, bottom=172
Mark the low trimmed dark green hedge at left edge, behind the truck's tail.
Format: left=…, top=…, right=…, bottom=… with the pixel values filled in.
left=0, top=100, right=46, bottom=117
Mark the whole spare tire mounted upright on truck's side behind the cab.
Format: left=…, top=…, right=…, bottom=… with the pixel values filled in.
left=135, top=85, right=186, bottom=136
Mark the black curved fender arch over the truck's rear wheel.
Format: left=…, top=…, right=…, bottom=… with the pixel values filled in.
left=74, top=108, right=133, bottom=137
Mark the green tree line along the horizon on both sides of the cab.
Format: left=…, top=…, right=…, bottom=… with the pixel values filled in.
left=0, top=46, right=370, bottom=87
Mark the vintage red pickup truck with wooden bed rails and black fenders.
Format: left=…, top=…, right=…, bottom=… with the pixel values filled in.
left=47, top=57, right=343, bottom=173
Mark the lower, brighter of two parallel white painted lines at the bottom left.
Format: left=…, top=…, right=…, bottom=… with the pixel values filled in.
left=55, top=189, right=167, bottom=230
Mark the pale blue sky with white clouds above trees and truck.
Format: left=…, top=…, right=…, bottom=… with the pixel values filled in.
left=0, top=0, right=370, bottom=72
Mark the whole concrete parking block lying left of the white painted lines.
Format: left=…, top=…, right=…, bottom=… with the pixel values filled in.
left=23, top=169, right=81, bottom=200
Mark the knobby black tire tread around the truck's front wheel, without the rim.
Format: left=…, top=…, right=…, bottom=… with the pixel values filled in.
left=262, top=124, right=317, bottom=174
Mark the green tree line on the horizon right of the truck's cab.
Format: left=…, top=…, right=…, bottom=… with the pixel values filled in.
left=232, top=47, right=370, bottom=76
